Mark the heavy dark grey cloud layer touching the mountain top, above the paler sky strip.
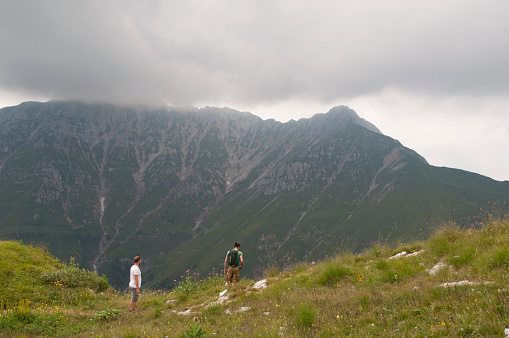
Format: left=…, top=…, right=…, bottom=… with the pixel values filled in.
left=0, top=0, right=509, bottom=104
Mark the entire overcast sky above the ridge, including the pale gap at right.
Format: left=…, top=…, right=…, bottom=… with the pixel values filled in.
left=0, top=0, right=509, bottom=180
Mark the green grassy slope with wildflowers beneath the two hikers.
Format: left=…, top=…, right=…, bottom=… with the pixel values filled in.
left=0, top=219, right=509, bottom=337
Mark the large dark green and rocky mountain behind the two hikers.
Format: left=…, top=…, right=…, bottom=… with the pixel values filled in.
left=0, top=101, right=509, bottom=288
